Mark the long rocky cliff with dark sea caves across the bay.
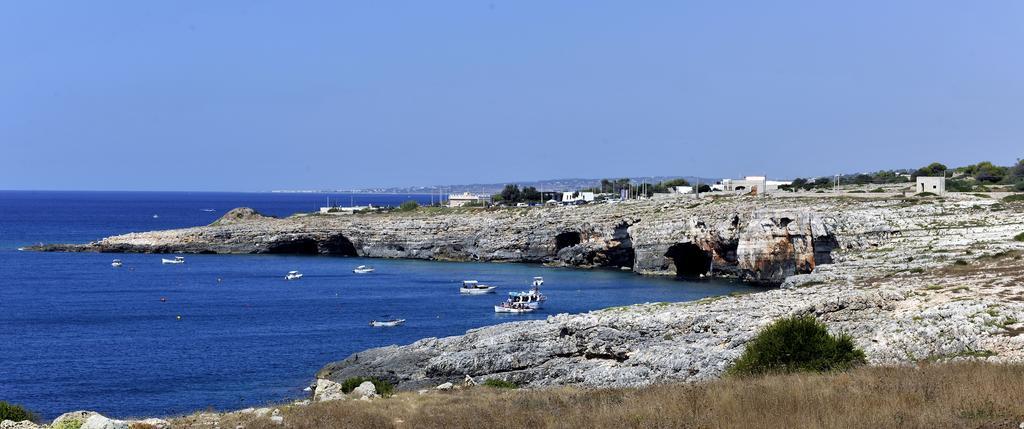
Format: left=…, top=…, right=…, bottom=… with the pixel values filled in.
left=35, top=198, right=841, bottom=284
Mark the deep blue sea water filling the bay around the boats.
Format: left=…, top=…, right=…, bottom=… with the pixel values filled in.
left=0, top=191, right=752, bottom=418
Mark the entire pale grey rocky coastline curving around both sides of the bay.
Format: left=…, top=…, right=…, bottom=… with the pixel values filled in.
left=14, top=195, right=1024, bottom=429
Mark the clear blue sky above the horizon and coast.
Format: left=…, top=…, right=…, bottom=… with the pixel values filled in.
left=0, top=0, right=1024, bottom=190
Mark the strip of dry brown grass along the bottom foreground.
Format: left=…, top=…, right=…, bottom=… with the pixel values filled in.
left=174, top=362, right=1024, bottom=428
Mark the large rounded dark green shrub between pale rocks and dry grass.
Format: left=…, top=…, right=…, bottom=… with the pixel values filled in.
left=729, top=316, right=865, bottom=375
